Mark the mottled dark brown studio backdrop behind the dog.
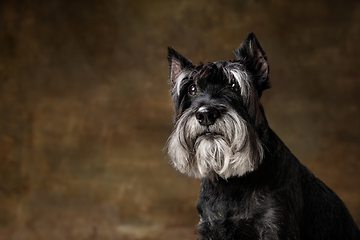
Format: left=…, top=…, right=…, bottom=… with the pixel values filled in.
left=0, top=0, right=360, bottom=240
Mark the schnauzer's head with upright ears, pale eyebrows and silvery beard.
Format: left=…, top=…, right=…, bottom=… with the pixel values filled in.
left=168, top=33, right=269, bottom=179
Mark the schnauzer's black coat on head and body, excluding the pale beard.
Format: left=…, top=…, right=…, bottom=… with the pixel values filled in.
left=168, top=33, right=360, bottom=240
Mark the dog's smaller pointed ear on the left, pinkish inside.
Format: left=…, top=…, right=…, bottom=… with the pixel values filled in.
left=167, top=47, right=192, bottom=84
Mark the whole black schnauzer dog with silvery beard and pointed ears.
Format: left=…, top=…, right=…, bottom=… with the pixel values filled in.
left=167, top=33, right=360, bottom=240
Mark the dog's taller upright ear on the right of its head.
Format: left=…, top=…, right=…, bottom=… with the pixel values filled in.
left=234, top=33, right=270, bottom=95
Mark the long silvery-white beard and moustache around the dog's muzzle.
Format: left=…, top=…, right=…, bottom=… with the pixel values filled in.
left=168, top=110, right=263, bottom=179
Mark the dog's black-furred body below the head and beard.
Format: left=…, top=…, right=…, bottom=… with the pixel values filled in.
left=197, top=130, right=360, bottom=240
